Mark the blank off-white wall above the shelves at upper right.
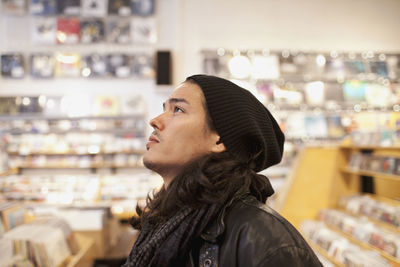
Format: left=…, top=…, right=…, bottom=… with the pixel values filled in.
left=180, top=0, right=400, bottom=80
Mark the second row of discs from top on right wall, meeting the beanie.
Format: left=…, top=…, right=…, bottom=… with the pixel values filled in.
left=256, top=80, right=400, bottom=109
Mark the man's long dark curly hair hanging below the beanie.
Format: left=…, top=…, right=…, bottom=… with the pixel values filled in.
left=130, top=151, right=273, bottom=229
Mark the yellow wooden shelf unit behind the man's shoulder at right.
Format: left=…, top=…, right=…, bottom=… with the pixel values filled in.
left=275, top=146, right=400, bottom=267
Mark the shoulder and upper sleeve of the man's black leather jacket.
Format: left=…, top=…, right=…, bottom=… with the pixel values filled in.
left=216, top=196, right=320, bottom=266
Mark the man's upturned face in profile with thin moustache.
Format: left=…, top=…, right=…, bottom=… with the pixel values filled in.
left=143, top=82, right=225, bottom=182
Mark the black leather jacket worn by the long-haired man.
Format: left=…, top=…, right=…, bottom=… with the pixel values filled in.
left=186, top=195, right=322, bottom=267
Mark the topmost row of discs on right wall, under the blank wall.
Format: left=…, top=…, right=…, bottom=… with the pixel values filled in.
left=203, top=48, right=400, bottom=82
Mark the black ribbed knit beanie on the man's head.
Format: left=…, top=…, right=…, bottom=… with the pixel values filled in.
left=187, top=75, right=285, bottom=172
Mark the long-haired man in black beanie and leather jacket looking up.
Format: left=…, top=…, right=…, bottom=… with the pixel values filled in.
left=124, top=75, right=322, bottom=267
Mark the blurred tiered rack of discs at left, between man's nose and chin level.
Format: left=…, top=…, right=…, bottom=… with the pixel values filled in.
left=0, top=114, right=147, bottom=174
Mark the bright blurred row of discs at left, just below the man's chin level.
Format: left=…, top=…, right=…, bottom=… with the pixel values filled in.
left=0, top=173, right=162, bottom=204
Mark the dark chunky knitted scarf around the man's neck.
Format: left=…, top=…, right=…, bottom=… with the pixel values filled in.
left=123, top=201, right=228, bottom=267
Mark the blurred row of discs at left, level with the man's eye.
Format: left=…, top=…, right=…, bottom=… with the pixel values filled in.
left=0, top=94, right=146, bottom=116
